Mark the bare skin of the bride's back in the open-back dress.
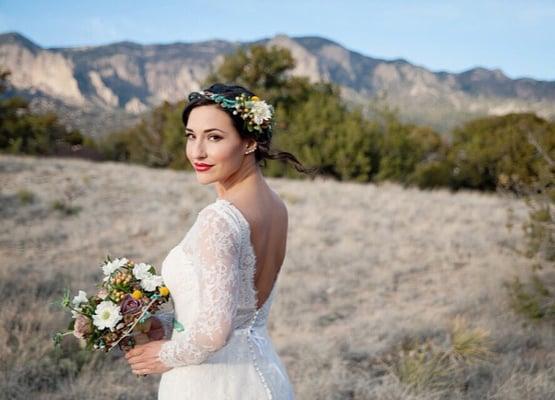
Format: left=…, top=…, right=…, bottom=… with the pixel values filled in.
left=224, top=190, right=288, bottom=309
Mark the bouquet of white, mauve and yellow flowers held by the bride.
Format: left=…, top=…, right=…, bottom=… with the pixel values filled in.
left=53, top=256, right=170, bottom=352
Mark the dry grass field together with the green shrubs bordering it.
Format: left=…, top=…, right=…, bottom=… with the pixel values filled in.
left=0, top=39, right=555, bottom=400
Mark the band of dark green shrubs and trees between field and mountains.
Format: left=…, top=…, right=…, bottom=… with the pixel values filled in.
left=0, top=45, right=555, bottom=191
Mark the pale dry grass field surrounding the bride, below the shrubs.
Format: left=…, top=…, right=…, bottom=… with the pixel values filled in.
left=0, top=155, right=555, bottom=400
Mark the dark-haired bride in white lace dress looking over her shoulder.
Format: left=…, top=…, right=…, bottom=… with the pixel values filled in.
left=126, top=84, right=313, bottom=400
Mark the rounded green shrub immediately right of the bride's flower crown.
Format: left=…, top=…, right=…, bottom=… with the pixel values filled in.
left=267, top=87, right=379, bottom=182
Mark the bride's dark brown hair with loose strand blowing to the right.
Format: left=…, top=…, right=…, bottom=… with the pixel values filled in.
left=181, top=83, right=319, bottom=177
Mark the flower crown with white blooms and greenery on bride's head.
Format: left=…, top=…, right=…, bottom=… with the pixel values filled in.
left=189, top=90, right=274, bottom=139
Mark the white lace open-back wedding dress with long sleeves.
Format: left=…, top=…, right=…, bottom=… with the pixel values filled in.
left=158, top=198, right=294, bottom=400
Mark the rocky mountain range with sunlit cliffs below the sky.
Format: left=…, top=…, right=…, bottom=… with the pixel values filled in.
left=0, top=32, right=555, bottom=136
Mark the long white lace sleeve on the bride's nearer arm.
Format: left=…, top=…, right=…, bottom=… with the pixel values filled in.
left=159, top=208, right=239, bottom=367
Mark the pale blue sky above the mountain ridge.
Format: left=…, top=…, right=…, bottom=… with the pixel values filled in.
left=0, top=0, right=555, bottom=81
